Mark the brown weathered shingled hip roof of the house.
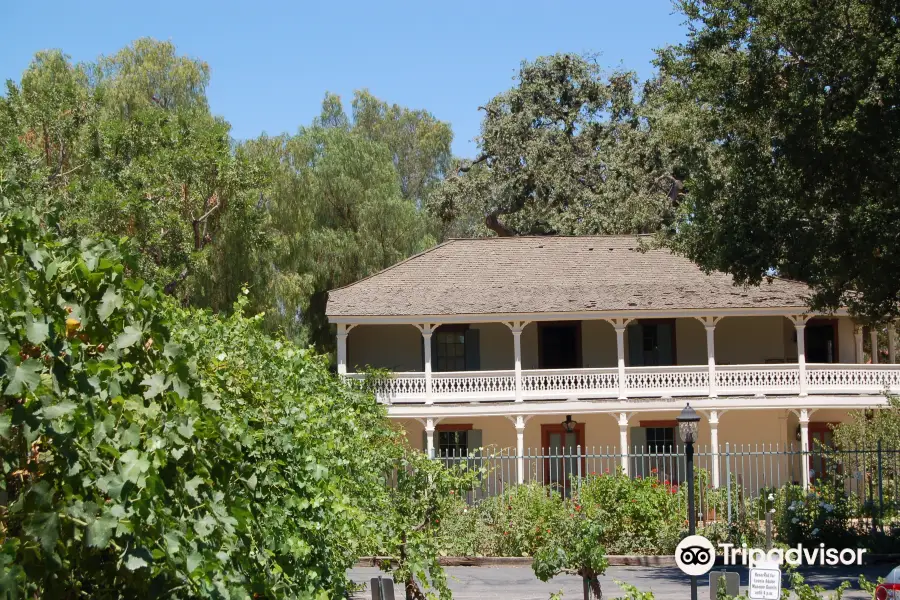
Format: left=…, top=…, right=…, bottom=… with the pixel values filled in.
left=326, top=236, right=809, bottom=317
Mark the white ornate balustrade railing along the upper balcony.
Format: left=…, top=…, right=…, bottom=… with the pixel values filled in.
left=347, top=364, right=900, bottom=404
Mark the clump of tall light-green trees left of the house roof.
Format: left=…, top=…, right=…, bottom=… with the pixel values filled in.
left=0, top=39, right=452, bottom=350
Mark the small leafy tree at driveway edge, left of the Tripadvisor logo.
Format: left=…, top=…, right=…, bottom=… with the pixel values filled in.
left=531, top=504, right=609, bottom=600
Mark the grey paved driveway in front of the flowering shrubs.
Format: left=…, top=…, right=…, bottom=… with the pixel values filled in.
left=350, top=565, right=891, bottom=600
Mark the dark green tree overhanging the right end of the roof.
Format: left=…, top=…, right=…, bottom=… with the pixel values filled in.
left=656, top=0, right=900, bottom=321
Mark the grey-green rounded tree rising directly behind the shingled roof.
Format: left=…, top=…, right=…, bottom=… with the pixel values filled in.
left=429, top=54, right=674, bottom=236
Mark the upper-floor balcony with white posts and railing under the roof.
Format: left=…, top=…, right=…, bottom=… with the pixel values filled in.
left=346, top=315, right=900, bottom=404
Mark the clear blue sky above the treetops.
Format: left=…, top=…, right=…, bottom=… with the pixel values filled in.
left=0, top=0, right=684, bottom=156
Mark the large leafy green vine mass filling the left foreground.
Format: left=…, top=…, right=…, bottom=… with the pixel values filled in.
left=0, top=196, right=404, bottom=599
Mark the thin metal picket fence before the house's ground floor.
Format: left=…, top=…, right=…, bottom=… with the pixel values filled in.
left=435, top=444, right=900, bottom=527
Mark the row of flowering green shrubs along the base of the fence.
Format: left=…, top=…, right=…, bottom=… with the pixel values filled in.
left=439, top=470, right=765, bottom=556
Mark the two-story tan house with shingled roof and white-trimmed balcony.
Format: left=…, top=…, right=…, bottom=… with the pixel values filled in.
left=327, top=236, right=900, bottom=485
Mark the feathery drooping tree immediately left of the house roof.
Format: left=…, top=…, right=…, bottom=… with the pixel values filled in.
left=240, top=92, right=442, bottom=348
